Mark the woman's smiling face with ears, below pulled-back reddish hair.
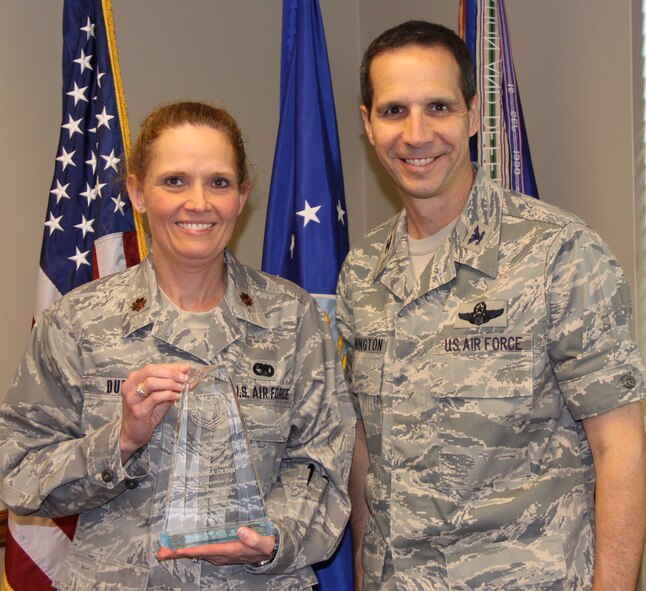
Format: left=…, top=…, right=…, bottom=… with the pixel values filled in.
left=128, top=124, right=249, bottom=269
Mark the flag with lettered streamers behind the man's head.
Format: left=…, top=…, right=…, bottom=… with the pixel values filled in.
left=460, top=0, right=538, bottom=197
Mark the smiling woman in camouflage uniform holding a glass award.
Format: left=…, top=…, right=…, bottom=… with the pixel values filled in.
left=0, top=103, right=354, bottom=590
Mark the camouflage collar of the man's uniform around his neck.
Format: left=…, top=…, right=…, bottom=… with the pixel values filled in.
left=373, top=165, right=502, bottom=301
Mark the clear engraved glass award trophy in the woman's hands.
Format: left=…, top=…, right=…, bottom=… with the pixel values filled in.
left=160, top=366, right=274, bottom=549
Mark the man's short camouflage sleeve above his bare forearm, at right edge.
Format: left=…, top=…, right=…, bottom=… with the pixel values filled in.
left=546, top=223, right=644, bottom=419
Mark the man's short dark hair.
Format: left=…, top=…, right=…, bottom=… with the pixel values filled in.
left=360, top=21, right=476, bottom=114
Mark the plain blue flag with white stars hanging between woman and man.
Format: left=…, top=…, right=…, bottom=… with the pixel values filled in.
left=262, top=0, right=353, bottom=591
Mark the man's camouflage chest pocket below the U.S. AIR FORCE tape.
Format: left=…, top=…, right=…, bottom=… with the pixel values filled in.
left=433, top=335, right=533, bottom=491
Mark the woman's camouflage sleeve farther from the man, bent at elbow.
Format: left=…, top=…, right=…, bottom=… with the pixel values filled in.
left=0, top=303, right=147, bottom=517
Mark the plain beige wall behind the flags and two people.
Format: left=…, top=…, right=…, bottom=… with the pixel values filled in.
left=0, top=0, right=646, bottom=584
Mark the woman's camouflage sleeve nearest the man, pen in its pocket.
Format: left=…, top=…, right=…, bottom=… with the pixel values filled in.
left=254, top=299, right=354, bottom=573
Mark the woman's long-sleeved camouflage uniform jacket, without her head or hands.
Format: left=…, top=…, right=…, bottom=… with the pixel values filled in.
left=0, top=253, right=354, bottom=591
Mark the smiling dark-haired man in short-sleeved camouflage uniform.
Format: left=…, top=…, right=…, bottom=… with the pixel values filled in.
left=337, top=22, right=646, bottom=591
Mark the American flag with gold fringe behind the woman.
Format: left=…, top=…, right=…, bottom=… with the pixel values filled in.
left=2, top=0, right=145, bottom=591
